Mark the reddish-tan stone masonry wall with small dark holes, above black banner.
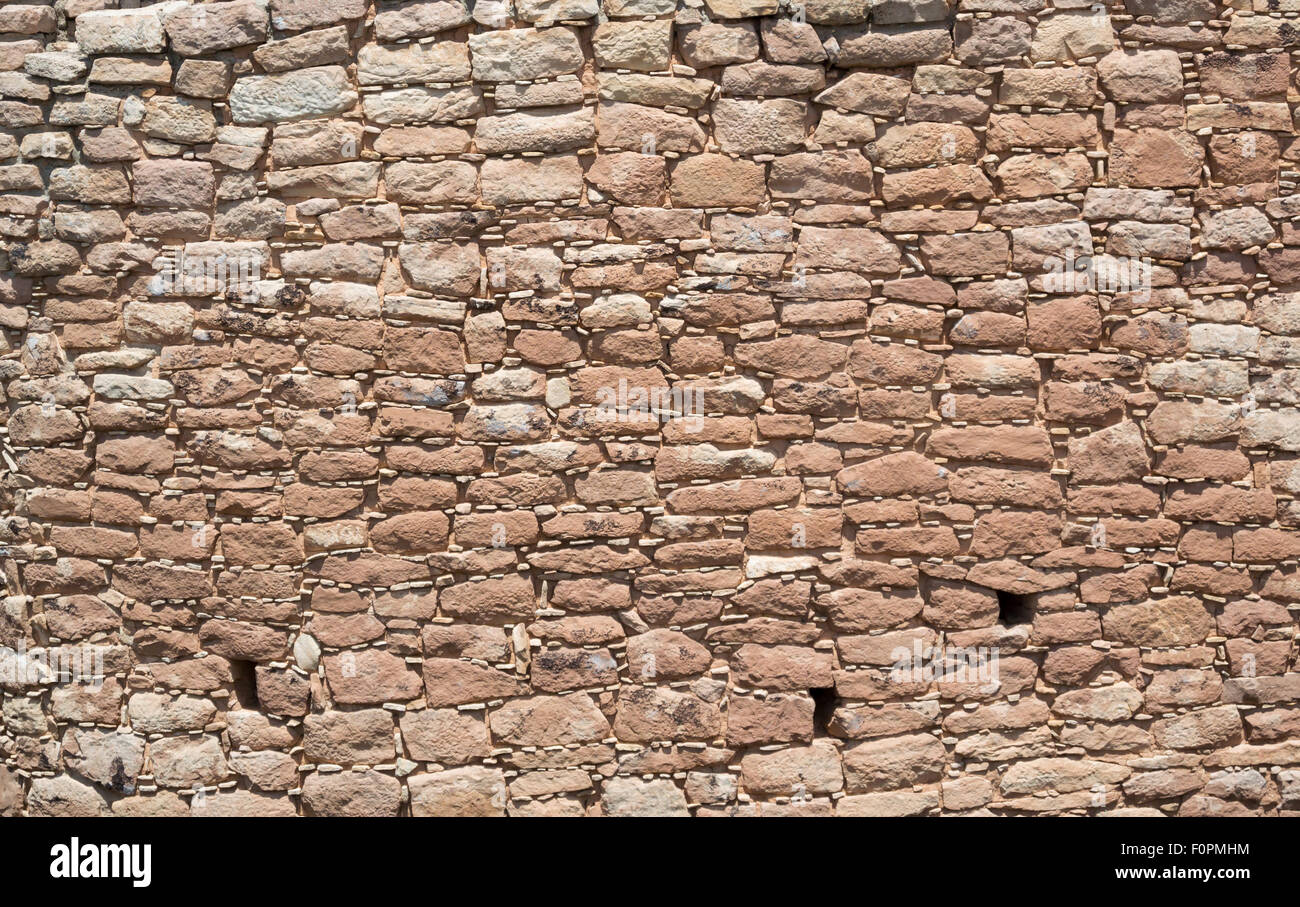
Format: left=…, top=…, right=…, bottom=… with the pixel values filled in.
left=0, top=0, right=1300, bottom=816
